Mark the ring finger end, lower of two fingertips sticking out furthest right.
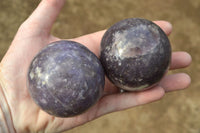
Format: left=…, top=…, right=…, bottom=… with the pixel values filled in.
left=159, top=73, right=191, bottom=92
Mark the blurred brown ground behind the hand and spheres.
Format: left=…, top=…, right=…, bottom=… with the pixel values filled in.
left=0, top=0, right=200, bottom=133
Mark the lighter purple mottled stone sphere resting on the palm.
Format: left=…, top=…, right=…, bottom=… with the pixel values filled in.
left=28, top=41, right=105, bottom=117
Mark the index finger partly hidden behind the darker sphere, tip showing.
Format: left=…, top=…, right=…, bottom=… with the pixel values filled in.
left=72, top=21, right=172, bottom=56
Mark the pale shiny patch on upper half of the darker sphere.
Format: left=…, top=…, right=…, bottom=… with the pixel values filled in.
left=110, top=24, right=160, bottom=59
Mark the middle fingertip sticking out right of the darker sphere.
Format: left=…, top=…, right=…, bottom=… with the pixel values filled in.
left=170, top=52, right=192, bottom=69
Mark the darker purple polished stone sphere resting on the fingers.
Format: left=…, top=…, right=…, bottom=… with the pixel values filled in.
left=100, top=18, right=171, bottom=91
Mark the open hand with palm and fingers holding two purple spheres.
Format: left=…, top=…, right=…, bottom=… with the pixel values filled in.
left=0, top=0, right=191, bottom=133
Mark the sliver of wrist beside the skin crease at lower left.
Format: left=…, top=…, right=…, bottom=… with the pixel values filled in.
left=0, top=84, right=15, bottom=133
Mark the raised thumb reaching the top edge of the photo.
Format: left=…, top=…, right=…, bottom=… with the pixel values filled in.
left=23, top=0, right=65, bottom=32
